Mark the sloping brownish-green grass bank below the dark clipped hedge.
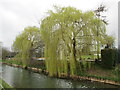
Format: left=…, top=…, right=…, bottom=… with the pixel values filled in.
left=83, top=65, right=120, bottom=82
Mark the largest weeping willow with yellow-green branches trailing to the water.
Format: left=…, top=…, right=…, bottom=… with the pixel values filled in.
left=40, top=6, right=106, bottom=76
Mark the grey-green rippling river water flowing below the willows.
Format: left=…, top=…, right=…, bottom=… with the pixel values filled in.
left=0, top=65, right=118, bottom=88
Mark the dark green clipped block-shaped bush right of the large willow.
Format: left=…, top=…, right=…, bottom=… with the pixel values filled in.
left=101, top=49, right=117, bottom=69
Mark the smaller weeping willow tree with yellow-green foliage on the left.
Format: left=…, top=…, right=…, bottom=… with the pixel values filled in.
left=13, top=27, right=41, bottom=66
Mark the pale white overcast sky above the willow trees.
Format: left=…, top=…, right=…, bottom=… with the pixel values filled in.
left=0, top=0, right=119, bottom=49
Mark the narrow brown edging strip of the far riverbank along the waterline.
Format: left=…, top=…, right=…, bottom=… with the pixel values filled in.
left=2, top=59, right=120, bottom=86
